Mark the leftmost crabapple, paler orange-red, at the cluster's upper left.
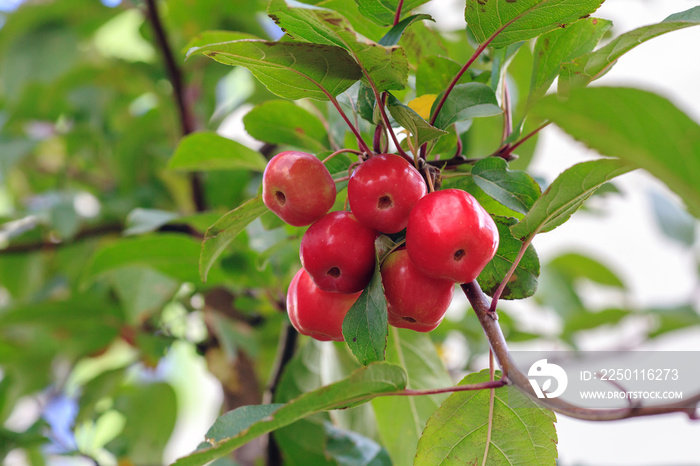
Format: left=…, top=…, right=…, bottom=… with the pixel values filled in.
left=262, top=151, right=336, bottom=226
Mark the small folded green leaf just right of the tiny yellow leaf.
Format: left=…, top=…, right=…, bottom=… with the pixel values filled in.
left=430, top=83, right=503, bottom=129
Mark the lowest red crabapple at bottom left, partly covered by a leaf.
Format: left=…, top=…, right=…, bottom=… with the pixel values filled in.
left=287, top=269, right=362, bottom=341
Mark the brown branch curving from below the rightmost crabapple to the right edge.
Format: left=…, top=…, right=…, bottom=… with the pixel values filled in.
left=462, top=281, right=700, bottom=421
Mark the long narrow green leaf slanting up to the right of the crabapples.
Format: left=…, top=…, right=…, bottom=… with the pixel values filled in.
left=510, top=159, right=632, bottom=239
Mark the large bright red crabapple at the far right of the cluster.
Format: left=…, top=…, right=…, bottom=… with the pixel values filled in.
left=406, top=189, right=499, bottom=283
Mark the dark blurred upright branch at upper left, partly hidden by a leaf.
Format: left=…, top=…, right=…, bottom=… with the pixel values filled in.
left=146, top=0, right=207, bottom=212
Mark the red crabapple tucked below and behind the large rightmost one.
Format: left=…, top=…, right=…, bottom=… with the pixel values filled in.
left=381, top=249, right=454, bottom=332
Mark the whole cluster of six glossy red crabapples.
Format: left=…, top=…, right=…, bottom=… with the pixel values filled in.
left=262, top=151, right=498, bottom=341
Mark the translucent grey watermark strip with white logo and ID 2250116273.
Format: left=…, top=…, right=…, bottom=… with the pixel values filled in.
left=511, top=351, right=700, bottom=408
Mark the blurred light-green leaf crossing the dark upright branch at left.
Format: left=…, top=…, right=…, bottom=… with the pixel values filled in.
left=168, top=132, right=267, bottom=172
